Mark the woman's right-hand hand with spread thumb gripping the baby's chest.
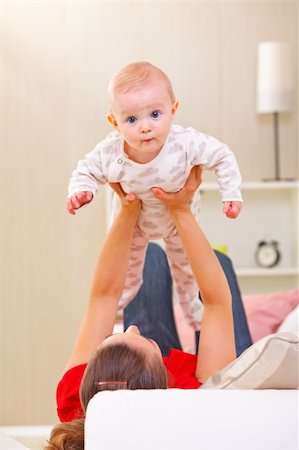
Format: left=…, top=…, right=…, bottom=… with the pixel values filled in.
left=152, top=166, right=202, bottom=212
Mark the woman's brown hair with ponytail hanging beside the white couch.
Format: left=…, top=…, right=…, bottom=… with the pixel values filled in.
left=45, top=344, right=167, bottom=450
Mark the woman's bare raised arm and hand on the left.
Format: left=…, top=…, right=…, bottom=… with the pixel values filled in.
left=65, top=186, right=141, bottom=370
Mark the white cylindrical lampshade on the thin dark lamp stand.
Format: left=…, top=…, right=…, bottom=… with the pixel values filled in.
left=257, top=42, right=294, bottom=113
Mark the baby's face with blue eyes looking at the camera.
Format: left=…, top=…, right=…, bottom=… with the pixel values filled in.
left=108, top=79, right=177, bottom=163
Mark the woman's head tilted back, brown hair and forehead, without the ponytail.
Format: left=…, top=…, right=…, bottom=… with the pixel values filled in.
left=80, top=326, right=167, bottom=410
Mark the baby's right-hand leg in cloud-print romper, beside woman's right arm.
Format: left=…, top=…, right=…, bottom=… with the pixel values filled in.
left=165, top=235, right=203, bottom=331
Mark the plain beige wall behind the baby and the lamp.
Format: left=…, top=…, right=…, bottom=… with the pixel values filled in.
left=0, top=0, right=298, bottom=425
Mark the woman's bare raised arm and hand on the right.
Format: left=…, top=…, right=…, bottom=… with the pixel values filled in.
left=153, top=167, right=236, bottom=382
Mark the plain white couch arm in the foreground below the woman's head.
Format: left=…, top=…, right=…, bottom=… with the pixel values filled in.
left=85, top=389, right=299, bottom=450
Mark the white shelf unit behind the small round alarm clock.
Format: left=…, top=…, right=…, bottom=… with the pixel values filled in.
left=200, top=180, right=299, bottom=295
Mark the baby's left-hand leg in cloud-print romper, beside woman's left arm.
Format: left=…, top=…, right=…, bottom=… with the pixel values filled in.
left=116, top=229, right=148, bottom=309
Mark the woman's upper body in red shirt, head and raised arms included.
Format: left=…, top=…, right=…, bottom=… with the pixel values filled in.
left=47, top=167, right=241, bottom=450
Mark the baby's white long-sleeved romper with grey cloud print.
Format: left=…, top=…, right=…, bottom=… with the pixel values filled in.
left=69, top=125, right=242, bottom=330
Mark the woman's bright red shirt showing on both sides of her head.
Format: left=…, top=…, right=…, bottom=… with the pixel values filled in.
left=56, top=349, right=201, bottom=422
